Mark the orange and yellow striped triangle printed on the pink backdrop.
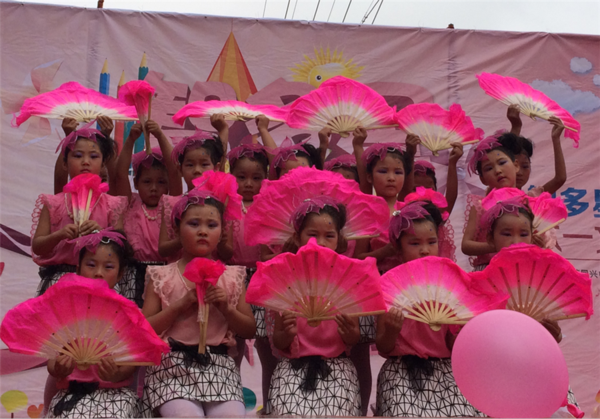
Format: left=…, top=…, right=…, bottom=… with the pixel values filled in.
left=206, top=32, right=257, bottom=102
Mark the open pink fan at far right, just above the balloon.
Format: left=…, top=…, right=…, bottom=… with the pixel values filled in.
left=470, top=244, right=594, bottom=321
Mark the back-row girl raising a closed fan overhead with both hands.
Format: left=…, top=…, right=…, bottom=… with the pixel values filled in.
left=116, top=120, right=181, bottom=308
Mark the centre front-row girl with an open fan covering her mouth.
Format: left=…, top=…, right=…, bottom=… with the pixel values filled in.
left=267, top=197, right=361, bottom=416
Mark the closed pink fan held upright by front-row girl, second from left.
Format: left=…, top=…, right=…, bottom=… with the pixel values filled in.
left=183, top=258, right=225, bottom=354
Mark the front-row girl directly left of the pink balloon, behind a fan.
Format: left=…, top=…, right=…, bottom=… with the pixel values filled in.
left=375, top=201, right=481, bottom=417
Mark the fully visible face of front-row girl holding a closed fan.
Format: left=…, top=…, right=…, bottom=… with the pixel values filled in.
left=179, top=205, right=221, bottom=258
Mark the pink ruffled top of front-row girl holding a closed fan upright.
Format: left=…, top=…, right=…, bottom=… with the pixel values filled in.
left=146, top=262, right=246, bottom=347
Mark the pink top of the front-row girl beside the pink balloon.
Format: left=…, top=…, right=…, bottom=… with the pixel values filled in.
left=381, top=319, right=451, bottom=358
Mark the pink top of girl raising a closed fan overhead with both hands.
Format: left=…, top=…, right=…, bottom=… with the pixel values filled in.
left=123, top=193, right=165, bottom=262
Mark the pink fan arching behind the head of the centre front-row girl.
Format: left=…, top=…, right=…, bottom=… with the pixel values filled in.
left=244, top=167, right=389, bottom=246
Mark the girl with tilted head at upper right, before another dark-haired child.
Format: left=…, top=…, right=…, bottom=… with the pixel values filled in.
left=462, top=136, right=519, bottom=271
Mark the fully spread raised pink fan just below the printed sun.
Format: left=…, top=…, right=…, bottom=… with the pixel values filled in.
left=287, top=76, right=396, bottom=137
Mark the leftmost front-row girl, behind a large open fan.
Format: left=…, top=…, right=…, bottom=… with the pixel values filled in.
left=46, top=230, right=139, bottom=418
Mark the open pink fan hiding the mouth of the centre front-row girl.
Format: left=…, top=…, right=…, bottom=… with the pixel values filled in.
left=246, top=238, right=385, bottom=326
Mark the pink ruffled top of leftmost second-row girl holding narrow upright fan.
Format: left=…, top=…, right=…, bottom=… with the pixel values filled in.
left=31, top=192, right=127, bottom=266
